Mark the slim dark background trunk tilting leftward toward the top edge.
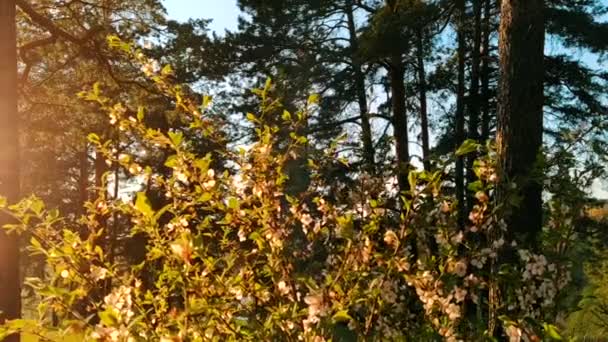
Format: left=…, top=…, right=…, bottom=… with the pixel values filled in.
left=346, top=1, right=376, bottom=173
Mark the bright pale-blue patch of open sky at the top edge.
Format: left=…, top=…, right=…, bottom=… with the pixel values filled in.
left=163, top=0, right=240, bottom=33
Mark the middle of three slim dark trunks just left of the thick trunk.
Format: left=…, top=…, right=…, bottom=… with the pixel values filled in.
left=467, top=0, right=481, bottom=211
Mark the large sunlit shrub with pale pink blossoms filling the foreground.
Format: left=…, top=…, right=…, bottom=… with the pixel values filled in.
left=0, top=39, right=568, bottom=341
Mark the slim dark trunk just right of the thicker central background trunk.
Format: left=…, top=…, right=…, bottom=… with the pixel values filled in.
left=416, top=29, right=431, bottom=171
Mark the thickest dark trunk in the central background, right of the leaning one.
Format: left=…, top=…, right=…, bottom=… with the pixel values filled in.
left=389, top=54, right=410, bottom=191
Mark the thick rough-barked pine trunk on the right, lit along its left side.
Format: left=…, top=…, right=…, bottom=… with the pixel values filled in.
left=496, top=0, right=545, bottom=248
